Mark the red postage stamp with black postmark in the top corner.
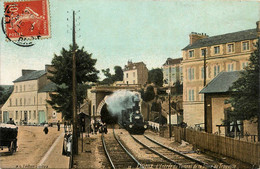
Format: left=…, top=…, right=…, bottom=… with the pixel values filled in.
left=4, top=0, right=50, bottom=41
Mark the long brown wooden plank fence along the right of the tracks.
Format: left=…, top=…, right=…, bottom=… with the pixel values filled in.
left=174, top=127, right=260, bottom=166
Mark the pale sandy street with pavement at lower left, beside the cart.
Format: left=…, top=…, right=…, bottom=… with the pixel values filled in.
left=0, top=126, right=69, bottom=168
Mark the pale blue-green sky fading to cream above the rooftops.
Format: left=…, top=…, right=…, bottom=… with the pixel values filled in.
left=0, top=0, right=260, bottom=85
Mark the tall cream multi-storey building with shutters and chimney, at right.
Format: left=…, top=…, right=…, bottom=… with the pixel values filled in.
left=182, top=22, right=260, bottom=127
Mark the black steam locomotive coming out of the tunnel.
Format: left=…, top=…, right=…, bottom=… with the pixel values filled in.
left=121, top=97, right=148, bottom=134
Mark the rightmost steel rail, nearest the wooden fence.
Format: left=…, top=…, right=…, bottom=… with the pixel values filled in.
left=144, top=135, right=215, bottom=168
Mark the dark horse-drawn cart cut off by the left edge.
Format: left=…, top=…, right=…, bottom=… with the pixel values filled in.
left=0, top=123, right=18, bottom=154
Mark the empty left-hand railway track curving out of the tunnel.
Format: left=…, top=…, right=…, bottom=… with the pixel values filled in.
left=101, top=129, right=143, bottom=168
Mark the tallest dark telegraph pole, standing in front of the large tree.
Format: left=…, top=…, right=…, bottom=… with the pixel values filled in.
left=72, top=11, right=78, bottom=155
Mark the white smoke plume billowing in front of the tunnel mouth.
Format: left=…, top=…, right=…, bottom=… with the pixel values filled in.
left=105, top=90, right=140, bottom=116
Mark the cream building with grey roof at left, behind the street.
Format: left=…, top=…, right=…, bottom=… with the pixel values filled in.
left=2, top=65, right=62, bottom=125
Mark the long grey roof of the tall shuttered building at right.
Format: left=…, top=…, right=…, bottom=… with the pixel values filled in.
left=182, top=29, right=257, bottom=50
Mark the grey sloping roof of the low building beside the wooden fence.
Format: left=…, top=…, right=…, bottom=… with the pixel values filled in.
left=200, top=71, right=241, bottom=93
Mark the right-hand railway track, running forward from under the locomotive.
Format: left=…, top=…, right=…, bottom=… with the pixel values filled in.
left=131, top=135, right=218, bottom=168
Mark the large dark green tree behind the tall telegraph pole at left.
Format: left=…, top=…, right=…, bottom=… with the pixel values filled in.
left=47, top=45, right=98, bottom=120
